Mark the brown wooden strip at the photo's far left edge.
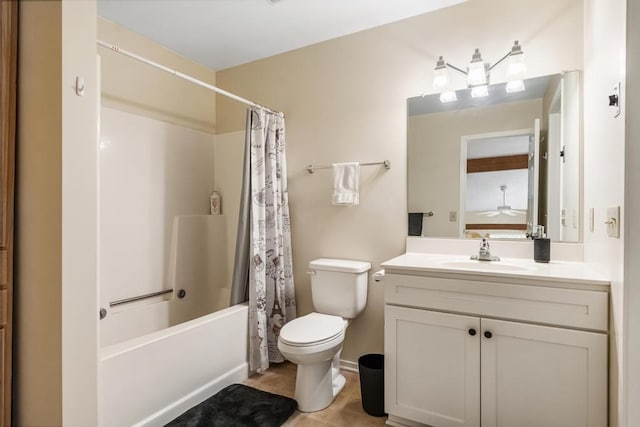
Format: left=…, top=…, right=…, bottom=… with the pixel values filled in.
left=0, top=1, right=18, bottom=426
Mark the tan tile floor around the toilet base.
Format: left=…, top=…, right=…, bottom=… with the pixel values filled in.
left=247, top=362, right=387, bottom=427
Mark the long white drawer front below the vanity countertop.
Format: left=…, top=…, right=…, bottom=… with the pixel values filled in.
left=384, top=274, right=608, bottom=331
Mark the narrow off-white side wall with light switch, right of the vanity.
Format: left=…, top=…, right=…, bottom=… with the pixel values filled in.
left=583, top=0, right=637, bottom=426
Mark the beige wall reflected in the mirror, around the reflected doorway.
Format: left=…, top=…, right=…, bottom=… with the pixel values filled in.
left=407, top=99, right=542, bottom=241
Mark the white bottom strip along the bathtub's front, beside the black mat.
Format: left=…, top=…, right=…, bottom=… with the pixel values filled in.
left=134, top=362, right=249, bottom=427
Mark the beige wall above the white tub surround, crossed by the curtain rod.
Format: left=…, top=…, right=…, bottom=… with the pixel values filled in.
left=98, top=17, right=216, bottom=133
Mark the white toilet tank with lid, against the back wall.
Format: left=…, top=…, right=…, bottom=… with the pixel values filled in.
left=309, top=258, right=371, bottom=319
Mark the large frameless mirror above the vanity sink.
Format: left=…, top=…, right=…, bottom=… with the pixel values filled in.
left=407, top=71, right=582, bottom=242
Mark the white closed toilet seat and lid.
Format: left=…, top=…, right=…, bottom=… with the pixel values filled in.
left=280, top=313, right=346, bottom=347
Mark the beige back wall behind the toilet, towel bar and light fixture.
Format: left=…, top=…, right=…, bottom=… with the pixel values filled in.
left=216, top=0, right=583, bottom=361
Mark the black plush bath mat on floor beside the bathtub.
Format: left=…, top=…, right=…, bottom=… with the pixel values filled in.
left=165, top=384, right=298, bottom=427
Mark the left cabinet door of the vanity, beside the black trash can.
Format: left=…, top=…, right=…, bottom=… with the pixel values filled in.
left=385, top=305, right=480, bottom=427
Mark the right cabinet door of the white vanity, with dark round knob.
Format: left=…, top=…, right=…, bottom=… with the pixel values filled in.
left=481, top=319, right=607, bottom=427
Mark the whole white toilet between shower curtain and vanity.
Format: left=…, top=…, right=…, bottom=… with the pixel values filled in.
left=278, top=258, right=371, bottom=412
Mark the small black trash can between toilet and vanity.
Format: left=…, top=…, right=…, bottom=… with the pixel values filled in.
left=358, top=354, right=385, bottom=417
